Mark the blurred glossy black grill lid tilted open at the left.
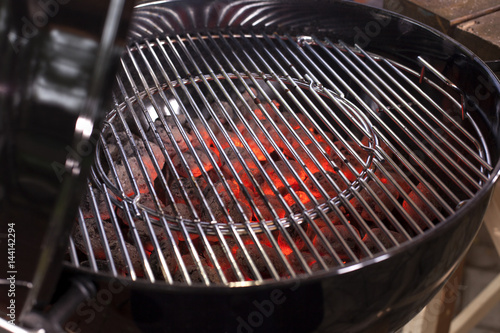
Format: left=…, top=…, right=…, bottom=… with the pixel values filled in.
left=0, top=0, right=133, bottom=321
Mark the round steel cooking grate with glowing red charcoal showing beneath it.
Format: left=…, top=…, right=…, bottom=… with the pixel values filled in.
left=65, top=31, right=491, bottom=285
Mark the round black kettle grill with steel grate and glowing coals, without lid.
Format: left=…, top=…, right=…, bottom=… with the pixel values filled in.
left=0, top=1, right=498, bottom=332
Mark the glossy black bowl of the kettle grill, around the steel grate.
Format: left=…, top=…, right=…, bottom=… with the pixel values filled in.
left=64, top=1, right=500, bottom=332
